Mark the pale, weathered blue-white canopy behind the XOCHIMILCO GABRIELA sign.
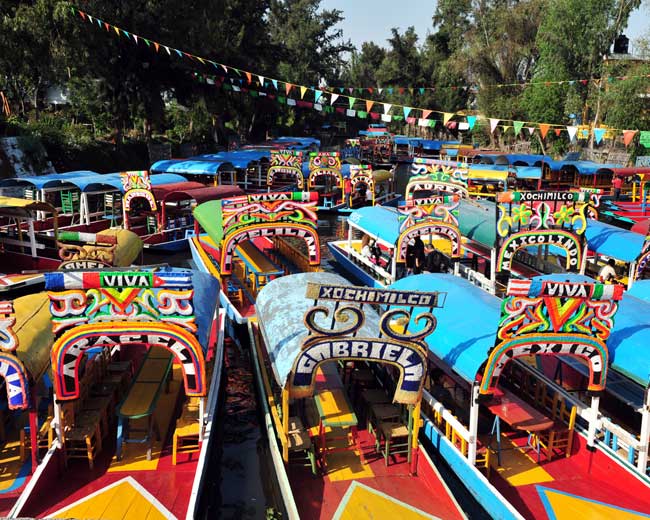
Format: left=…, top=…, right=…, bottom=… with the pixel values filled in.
left=255, top=272, right=379, bottom=388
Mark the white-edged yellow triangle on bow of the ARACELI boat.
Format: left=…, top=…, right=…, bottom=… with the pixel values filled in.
left=50, top=477, right=173, bottom=520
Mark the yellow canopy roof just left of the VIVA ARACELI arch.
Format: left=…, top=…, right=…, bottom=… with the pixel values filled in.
left=14, top=292, right=54, bottom=381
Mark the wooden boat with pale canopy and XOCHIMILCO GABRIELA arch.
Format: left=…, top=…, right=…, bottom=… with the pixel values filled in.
left=248, top=273, right=464, bottom=519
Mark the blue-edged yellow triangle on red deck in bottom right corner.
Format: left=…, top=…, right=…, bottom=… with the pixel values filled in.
left=539, top=488, right=648, bottom=520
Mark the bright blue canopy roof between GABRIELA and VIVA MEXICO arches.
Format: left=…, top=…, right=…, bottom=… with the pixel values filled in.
left=389, top=274, right=501, bottom=383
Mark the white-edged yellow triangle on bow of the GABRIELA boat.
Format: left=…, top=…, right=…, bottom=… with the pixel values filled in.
left=333, top=482, right=436, bottom=520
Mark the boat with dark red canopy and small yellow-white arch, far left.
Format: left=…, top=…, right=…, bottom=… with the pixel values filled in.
left=122, top=171, right=242, bottom=252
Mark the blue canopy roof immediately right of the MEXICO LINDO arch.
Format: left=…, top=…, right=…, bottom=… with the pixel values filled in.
left=585, top=219, right=645, bottom=263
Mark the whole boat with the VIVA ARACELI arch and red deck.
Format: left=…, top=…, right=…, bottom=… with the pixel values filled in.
left=9, top=269, right=223, bottom=518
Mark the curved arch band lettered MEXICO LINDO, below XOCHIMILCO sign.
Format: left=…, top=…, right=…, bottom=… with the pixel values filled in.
left=496, top=229, right=583, bottom=271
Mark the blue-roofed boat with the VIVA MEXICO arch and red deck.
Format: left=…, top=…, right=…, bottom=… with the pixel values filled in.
left=391, top=274, right=650, bottom=519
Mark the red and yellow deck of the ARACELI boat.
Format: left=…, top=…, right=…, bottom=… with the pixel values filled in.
left=20, top=365, right=198, bottom=519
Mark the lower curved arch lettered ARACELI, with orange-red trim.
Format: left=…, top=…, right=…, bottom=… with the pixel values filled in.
left=51, top=321, right=207, bottom=400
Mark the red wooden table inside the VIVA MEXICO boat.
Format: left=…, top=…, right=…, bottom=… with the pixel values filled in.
left=487, top=389, right=553, bottom=465
